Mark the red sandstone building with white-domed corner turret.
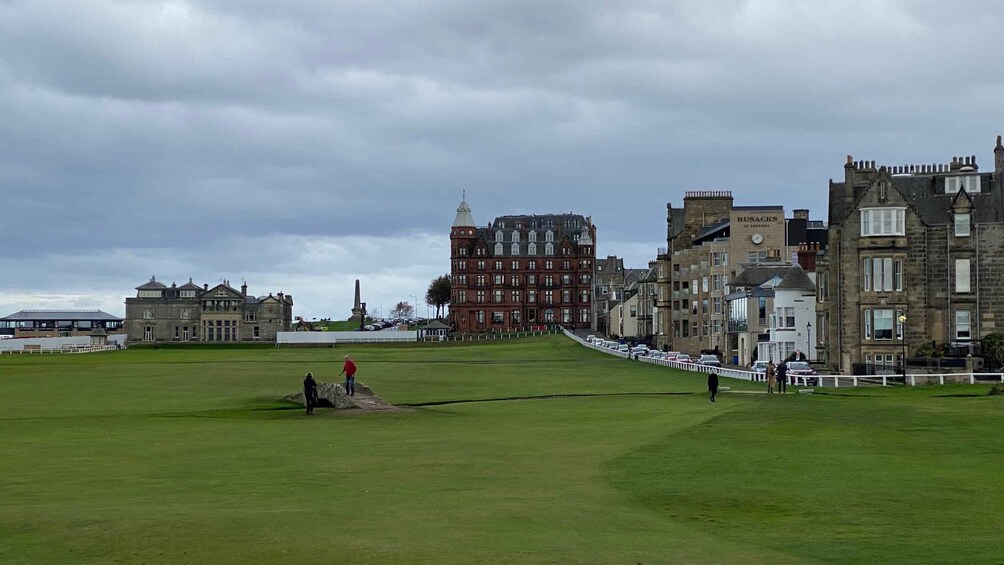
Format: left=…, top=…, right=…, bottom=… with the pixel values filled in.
left=450, top=201, right=596, bottom=333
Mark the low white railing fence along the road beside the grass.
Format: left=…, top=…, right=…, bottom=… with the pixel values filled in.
left=564, top=330, right=1004, bottom=388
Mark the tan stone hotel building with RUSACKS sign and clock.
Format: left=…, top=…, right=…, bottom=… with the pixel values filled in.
left=655, top=191, right=826, bottom=358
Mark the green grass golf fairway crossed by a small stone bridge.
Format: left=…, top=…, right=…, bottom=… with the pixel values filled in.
left=0, top=336, right=1004, bottom=565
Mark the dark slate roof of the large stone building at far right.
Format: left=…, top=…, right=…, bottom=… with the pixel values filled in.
left=829, top=173, right=1004, bottom=226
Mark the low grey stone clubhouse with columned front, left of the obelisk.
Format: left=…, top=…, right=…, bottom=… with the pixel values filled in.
left=126, top=278, right=293, bottom=343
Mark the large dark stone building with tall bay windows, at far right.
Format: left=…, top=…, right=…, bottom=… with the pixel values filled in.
left=816, top=136, right=1004, bottom=373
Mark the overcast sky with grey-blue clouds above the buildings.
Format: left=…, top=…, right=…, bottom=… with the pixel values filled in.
left=0, top=0, right=1004, bottom=319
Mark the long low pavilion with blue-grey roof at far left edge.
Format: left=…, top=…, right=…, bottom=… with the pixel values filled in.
left=0, top=310, right=122, bottom=337
